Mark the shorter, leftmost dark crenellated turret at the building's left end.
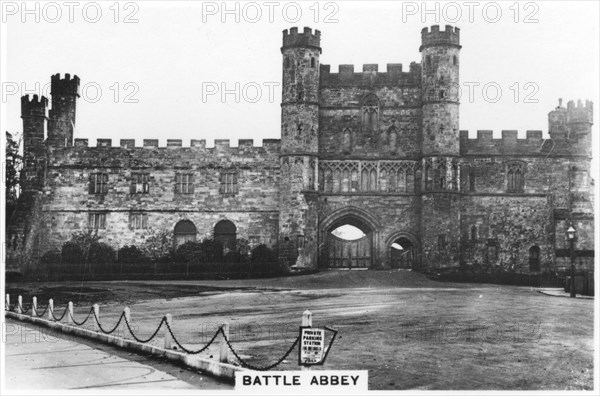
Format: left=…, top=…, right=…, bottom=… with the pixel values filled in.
left=21, top=95, right=48, bottom=192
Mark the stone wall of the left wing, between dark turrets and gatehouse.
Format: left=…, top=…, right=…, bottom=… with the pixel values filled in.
left=34, top=141, right=279, bottom=254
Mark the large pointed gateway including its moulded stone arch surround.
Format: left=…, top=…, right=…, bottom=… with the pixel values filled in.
left=319, top=206, right=381, bottom=269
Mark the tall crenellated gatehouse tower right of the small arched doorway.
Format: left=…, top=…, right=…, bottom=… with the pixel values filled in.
left=419, top=26, right=461, bottom=266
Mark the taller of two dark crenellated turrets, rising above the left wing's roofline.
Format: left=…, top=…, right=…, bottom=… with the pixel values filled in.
left=48, top=73, right=79, bottom=148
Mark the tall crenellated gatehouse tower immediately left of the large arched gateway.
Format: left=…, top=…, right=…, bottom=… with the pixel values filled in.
left=279, top=27, right=321, bottom=268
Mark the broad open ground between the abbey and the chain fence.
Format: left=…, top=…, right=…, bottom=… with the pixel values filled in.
left=7, top=271, right=595, bottom=390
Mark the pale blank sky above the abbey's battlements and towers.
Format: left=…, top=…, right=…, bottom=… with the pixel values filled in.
left=1, top=1, right=600, bottom=157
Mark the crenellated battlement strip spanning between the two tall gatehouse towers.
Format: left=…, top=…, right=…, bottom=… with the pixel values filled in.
left=320, top=62, right=421, bottom=87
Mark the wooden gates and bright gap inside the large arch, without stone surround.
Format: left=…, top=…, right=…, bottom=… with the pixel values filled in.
left=326, top=216, right=373, bottom=268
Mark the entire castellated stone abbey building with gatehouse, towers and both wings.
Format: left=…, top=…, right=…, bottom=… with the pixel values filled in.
left=7, top=26, right=594, bottom=273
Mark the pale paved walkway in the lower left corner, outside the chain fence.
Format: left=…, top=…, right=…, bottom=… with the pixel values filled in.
left=3, top=318, right=232, bottom=390
